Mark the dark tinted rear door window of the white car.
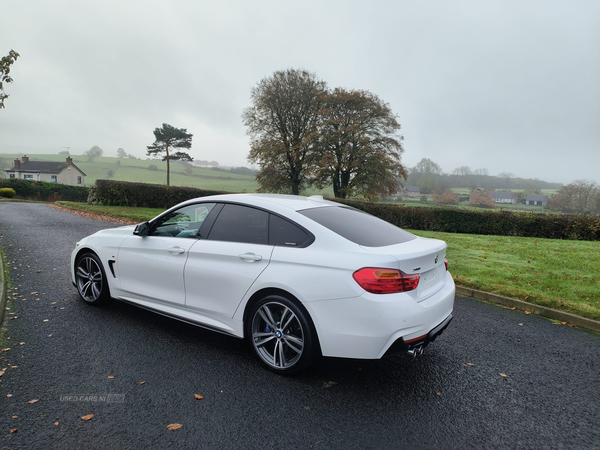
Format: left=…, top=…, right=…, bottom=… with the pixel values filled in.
left=208, top=204, right=269, bottom=245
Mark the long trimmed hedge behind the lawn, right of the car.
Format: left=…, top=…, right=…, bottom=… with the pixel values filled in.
left=337, top=200, right=600, bottom=241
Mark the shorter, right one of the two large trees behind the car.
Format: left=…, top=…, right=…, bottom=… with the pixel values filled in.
left=315, top=88, right=407, bottom=198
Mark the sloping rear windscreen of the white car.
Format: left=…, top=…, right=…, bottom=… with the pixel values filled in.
left=298, top=206, right=416, bottom=247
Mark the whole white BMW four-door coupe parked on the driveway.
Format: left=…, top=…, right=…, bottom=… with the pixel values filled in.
left=71, top=194, right=455, bottom=374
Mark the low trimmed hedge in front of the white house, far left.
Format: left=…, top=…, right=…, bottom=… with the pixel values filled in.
left=0, top=178, right=89, bottom=202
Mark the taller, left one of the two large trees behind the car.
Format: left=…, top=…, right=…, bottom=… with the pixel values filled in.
left=242, top=69, right=327, bottom=195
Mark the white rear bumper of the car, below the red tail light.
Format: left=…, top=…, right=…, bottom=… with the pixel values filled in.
left=304, top=272, right=455, bottom=359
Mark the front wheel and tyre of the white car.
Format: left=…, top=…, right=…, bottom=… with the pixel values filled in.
left=75, top=253, right=110, bottom=305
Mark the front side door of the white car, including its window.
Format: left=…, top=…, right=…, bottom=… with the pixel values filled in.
left=116, top=203, right=215, bottom=307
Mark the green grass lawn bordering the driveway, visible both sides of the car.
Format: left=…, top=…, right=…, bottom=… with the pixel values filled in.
left=57, top=202, right=600, bottom=320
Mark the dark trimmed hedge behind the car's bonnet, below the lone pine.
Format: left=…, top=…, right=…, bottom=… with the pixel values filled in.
left=88, top=180, right=228, bottom=209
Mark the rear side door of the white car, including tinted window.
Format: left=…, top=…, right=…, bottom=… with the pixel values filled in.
left=184, top=204, right=273, bottom=318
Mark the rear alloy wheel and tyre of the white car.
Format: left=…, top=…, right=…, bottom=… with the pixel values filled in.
left=246, top=295, right=320, bottom=375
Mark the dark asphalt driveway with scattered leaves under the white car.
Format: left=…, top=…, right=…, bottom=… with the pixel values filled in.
left=0, top=203, right=600, bottom=449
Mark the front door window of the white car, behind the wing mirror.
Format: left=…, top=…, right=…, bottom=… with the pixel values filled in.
left=150, top=203, right=215, bottom=238
